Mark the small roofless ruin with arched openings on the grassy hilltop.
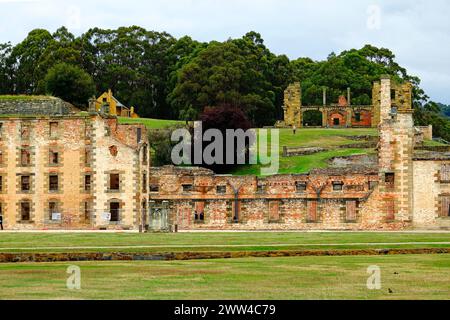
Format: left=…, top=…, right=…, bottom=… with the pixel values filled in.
left=277, top=82, right=412, bottom=128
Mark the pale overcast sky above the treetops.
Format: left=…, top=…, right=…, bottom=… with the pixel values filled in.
left=0, top=0, right=450, bottom=104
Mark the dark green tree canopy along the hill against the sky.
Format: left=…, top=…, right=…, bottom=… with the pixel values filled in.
left=0, top=26, right=448, bottom=140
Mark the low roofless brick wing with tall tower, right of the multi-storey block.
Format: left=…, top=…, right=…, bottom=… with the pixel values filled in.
left=149, top=77, right=450, bottom=230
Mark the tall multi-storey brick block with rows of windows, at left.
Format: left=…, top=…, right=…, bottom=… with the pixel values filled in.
left=0, top=97, right=149, bottom=229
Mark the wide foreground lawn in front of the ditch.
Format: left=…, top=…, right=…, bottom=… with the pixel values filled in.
left=0, top=255, right=450, bottom=300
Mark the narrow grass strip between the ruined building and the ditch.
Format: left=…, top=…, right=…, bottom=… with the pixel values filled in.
left=0, top=232, right=450, bottom=252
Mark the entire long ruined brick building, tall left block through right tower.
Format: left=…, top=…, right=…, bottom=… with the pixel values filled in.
left=0, top=77, right=450, bottom=231
